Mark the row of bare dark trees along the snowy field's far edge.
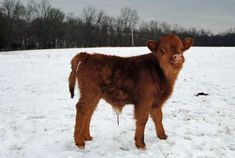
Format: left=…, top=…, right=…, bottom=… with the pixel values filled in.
left=0, top=0, right=235, bottom=50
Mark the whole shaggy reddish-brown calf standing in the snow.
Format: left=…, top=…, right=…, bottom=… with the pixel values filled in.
left=69, top=35, right=193, bottom=149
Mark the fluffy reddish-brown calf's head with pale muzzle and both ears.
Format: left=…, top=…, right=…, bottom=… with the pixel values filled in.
left=147, top=34, right=193, bottom=75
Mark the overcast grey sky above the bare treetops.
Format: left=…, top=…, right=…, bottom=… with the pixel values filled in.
left=0, top=0, right=235, bottom=33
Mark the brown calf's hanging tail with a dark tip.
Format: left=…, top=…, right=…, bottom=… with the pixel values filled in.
left=69, top=52, right=89, bottom=98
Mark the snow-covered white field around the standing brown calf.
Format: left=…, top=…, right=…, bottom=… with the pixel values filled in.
left=0, top=47, right=235, bottom=158
